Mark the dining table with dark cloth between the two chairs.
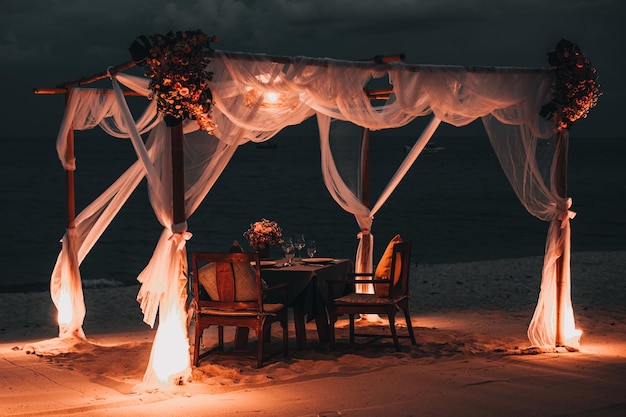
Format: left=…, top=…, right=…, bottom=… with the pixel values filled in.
left=235, top=258, right=354, bottom=350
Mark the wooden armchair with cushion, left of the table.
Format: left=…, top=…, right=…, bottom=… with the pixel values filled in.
left=191, top=252, right=289, bottom=368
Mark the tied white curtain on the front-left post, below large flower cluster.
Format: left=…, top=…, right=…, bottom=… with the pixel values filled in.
left=113, top=72, right=243, bottom=388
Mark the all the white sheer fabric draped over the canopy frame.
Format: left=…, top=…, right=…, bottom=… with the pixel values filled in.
left=51, top=51, right=573, bottom=385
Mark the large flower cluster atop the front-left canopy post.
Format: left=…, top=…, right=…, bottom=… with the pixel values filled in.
left=131, top=30, right=217, bottom=134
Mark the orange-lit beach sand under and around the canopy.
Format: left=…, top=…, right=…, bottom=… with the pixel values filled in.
left=0, top=252, right=626, bottom=417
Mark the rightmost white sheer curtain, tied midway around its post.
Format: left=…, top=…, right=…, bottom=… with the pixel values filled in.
left=483, top=117, right=580, bottom=349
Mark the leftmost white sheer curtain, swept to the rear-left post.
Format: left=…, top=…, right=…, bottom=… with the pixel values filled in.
left=50, top=88, right=156, bottom=339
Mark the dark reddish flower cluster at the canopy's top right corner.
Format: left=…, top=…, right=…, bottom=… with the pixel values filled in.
left=541, top=39, right=602, bottom=131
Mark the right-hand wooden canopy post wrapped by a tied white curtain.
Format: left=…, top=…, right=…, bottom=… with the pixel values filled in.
left=554, top=131, right=568, bottom=347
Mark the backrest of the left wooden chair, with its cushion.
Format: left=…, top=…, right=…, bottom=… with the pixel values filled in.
left=191, top=252, right=263, bottom=311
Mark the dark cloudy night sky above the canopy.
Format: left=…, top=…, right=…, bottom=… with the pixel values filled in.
left=0, top=0, right=626, bottom=140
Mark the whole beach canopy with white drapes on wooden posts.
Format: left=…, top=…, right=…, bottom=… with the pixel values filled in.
left=35, top=36, right=600, bottom=385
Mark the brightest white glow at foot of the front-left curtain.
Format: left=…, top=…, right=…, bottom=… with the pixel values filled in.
left=152, top=306, right=190, bottom=386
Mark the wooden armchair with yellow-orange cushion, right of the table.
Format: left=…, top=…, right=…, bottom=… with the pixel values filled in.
left=328, top=242, right=417, bottom=351
